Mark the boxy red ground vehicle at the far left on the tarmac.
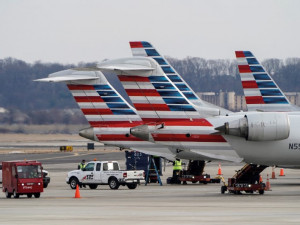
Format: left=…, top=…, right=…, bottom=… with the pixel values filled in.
left=2, top=161, right=43, bottom=198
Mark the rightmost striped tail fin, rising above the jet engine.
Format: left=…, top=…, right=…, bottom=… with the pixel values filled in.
left=235, top=51, right=292, bottom=111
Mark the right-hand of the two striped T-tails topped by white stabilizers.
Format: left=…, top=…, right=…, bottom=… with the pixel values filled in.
left=98, top=57, right=219, bottom=123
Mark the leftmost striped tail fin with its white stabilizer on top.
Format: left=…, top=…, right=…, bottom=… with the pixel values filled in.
left=37, top=68, right=141, bottom=127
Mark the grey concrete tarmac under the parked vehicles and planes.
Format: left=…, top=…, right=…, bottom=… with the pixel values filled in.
left=0, top=151, right=300, bottom=225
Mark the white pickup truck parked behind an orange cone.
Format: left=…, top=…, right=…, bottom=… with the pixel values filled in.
left=66, top=161, right=145, bottom=189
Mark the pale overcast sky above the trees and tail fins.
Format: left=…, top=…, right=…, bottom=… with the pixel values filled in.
left=0, top=0, right=300, bottom=63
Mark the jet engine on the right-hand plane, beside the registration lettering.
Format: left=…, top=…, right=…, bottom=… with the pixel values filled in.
left=224, top=112, right=290, bottom=141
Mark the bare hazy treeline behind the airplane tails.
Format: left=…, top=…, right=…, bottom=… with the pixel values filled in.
left=0, top=57, right=300, bottom=124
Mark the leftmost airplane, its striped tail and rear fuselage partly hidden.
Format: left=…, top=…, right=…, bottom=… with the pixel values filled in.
left=36, top=65, right=240, bottom=161
